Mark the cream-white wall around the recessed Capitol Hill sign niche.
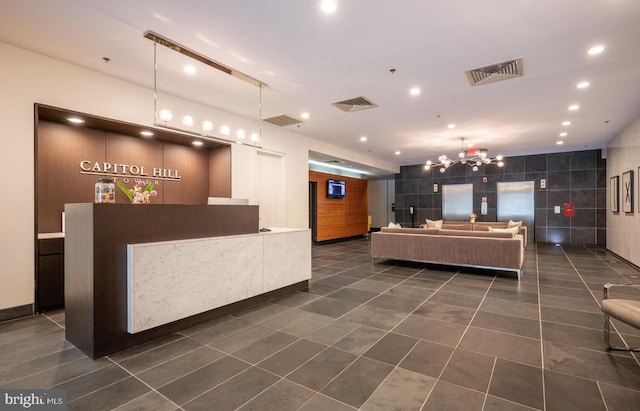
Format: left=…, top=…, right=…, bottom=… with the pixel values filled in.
left=0, top=43, right=398, bottom=310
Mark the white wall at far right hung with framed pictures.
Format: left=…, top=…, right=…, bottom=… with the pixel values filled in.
left=607, top=118, right=640, bottom=265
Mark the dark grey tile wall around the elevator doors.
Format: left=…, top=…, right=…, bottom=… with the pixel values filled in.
left=396, top=150, right=607, bottom=246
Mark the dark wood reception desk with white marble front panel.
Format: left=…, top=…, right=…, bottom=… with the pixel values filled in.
left=65, top=204, right=311, bottom=358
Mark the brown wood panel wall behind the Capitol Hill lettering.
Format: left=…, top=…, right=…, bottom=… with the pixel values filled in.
left=36, top=120, right=231, bottom=233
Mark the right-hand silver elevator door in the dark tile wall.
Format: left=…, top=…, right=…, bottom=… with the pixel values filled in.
left=497, top=181, right=536, bottom=242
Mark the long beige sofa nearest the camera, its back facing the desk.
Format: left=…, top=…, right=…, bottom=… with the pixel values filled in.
left=371, top=223, right=526, bottom=280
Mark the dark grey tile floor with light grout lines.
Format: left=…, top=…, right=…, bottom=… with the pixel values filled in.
left=0, top=239, right=640, bottom=411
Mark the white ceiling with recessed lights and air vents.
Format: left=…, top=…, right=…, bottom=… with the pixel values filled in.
left=0, top=0, right=640, bottom=175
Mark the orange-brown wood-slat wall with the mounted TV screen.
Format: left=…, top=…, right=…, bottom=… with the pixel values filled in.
left=309, top=171, right=369, bottom=241
